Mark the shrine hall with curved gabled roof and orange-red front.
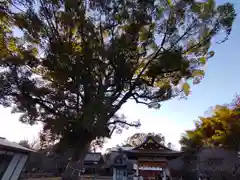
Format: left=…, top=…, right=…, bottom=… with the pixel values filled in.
left=125, top=136, right=182, bottom=180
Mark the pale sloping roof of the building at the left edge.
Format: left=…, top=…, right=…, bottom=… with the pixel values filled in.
left=0, top=137, right=33, bottom=152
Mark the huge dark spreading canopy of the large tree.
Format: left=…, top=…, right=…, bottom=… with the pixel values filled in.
left=0, top=0, right=236, bottom=158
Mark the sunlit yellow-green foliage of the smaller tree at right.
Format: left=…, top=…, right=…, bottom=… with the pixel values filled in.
left=180, top=97, right=240, bottom=150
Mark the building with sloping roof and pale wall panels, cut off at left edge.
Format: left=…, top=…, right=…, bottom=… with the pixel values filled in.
left=0, top=137, right=32, bottom=180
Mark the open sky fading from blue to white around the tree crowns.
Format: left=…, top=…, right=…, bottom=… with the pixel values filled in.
left=0, top=0, right=240, bottom=151
